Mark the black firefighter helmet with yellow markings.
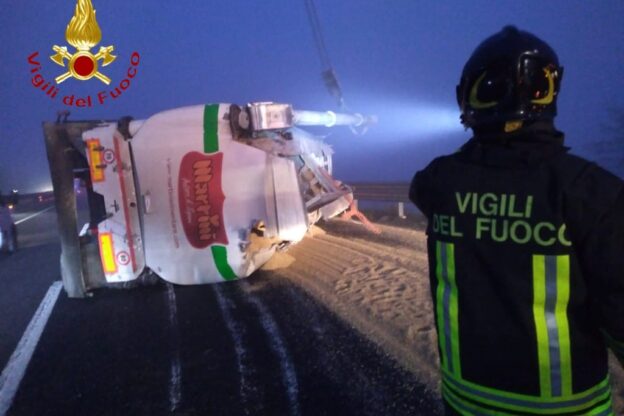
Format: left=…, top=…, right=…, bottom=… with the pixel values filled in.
left=457, top=26, right=563, bottom=132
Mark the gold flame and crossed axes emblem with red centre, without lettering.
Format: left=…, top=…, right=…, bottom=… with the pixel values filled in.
left=50, top=0, right=116, bottom=85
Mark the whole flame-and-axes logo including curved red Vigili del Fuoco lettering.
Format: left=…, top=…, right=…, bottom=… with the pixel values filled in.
left=28, top=0, right=141, bottom=107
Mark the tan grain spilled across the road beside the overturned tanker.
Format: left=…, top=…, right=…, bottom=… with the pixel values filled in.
left=267, top=220, right=624, bottom=414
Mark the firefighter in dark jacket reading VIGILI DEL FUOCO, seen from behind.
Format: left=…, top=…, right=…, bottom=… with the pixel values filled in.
left=410, top=26, right=624, bottom=415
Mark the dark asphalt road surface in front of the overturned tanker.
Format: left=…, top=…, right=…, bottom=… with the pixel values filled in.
left=0, top=206, right=440, bottom=416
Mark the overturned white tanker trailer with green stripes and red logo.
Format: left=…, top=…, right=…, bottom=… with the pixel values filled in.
left=44, top=103, right=371, bottom=297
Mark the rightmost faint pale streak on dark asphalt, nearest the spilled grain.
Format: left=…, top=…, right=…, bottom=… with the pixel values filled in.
left=243, top=282, right=301, bottom=416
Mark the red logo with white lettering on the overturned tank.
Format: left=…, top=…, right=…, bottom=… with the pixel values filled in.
left=178, top=152, right=228, bottom=248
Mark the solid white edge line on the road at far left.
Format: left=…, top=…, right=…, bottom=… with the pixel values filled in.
left=0, top=282, right=63, bottom=416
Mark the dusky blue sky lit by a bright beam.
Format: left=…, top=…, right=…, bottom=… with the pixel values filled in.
left=0, top=0, right=624, bottom=192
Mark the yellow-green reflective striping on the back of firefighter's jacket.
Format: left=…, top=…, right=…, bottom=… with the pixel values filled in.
left=435, top=247, right=614, bottom=416
